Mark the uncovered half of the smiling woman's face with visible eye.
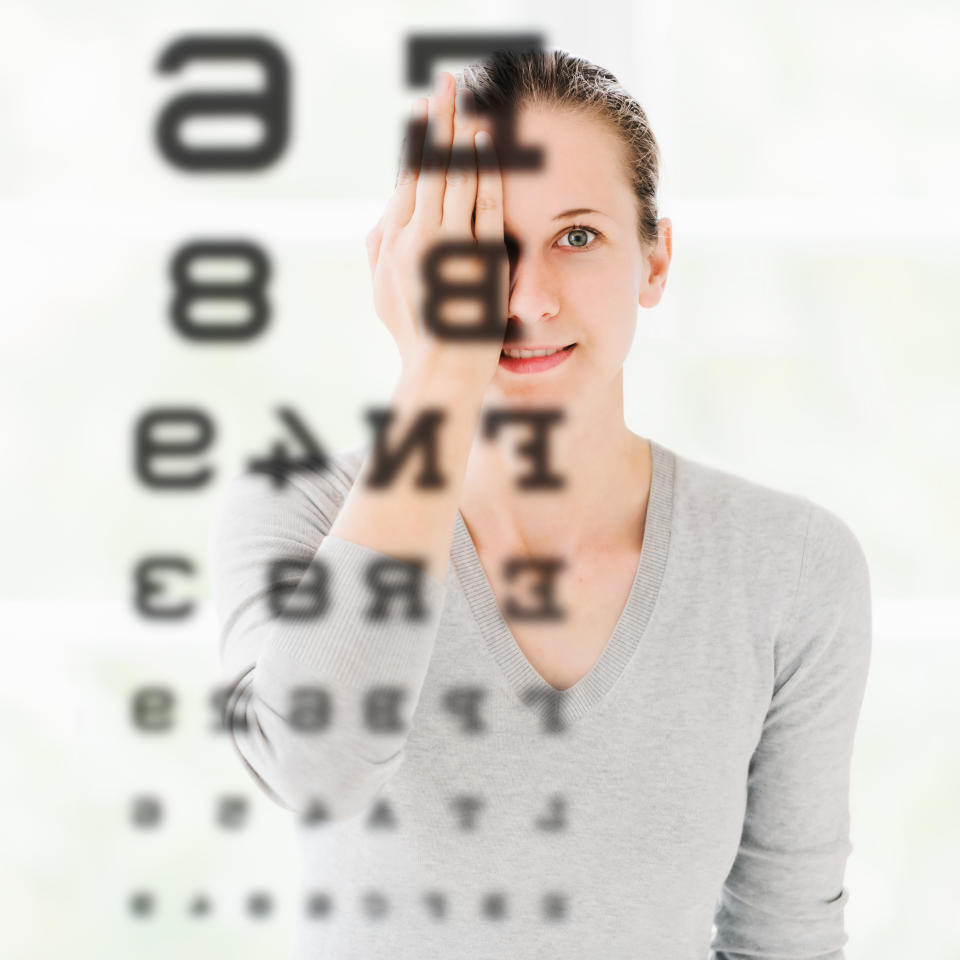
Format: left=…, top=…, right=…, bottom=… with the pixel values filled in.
left=478, top=107, right=670, bottom=405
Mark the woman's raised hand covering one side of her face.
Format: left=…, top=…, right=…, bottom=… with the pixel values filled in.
left=366, top=72, right=509, bottom=395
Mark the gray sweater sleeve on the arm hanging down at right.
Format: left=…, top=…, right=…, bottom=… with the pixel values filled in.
left=710, top=503, right=872, bottom=960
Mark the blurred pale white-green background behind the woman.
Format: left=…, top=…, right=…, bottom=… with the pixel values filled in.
left=0, top=0, right=960, bottom=960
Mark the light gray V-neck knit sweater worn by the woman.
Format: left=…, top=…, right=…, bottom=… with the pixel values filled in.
left=209, top=441, right=871, bottom=960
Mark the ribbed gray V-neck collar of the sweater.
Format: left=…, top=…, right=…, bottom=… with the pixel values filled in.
left=450, top=438, right=676, bottom=723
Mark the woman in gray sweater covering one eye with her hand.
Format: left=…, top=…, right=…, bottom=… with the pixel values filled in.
left=211, top=51, right=871, bottom=960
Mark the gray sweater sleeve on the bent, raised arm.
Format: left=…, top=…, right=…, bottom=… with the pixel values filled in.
left=207, top=455, right=445, bottom=820
